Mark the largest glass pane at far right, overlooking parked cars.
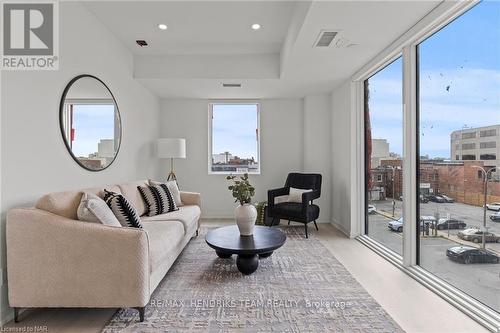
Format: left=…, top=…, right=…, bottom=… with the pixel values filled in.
left=417, top=1, right=500, bottom=312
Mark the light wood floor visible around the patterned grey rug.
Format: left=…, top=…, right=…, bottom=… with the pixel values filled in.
left=3, top=220, right=486, bottom=333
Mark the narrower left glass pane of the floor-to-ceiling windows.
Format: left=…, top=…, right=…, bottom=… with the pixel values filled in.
left=364, top=57, right=403, bottom=255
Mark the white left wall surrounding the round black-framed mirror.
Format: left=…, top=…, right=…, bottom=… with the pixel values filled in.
left=0, top=2, right=159, bottom=322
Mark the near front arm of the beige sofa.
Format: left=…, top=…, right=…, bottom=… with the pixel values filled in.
left=6, top=208, right=150, bottom=307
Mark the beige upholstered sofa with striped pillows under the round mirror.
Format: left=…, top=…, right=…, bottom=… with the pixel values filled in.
left=6, top=181, right=201, bottom=321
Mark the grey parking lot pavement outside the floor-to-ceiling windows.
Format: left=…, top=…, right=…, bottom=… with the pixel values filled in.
left=368, top=200, right=500, bottom=311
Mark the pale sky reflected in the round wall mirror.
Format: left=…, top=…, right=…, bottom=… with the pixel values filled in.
left=72, top=104, right=115, bottom=157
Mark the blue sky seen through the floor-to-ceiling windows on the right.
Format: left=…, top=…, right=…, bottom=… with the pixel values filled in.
left=369, top=1, right=500, bottom=158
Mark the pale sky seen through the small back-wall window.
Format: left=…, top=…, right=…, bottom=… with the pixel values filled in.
left=212, top=104, right=258, bottom=161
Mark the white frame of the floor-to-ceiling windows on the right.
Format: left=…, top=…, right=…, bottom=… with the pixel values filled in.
left=349, top=0, right=500, bottom=331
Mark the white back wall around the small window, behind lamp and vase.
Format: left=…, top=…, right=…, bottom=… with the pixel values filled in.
left=160, top=99, right=303, bottom=218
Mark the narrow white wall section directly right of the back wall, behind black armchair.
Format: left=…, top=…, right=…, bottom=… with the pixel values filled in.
left=303, top=93, right=332, bottom=223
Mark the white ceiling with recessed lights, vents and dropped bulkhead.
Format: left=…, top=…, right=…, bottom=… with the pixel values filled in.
left=81, top=1, right=440, bottom=98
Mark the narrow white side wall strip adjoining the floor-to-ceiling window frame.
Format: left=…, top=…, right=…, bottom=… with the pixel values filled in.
left=331, top=81, right=354, bottom=236
